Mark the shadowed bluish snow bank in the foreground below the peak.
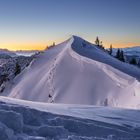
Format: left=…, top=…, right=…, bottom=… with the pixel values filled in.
left=0, top=97, right=140, bottom=140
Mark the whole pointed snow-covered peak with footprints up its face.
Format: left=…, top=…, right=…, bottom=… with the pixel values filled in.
left=3, top=36, right=140, bottom=108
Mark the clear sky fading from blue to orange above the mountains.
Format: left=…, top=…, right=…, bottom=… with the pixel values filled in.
left=0, top=0, right=140, bottom=50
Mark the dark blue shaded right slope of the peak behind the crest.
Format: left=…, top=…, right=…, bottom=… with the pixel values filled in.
left=71, top=36, right=140, bottom=81
